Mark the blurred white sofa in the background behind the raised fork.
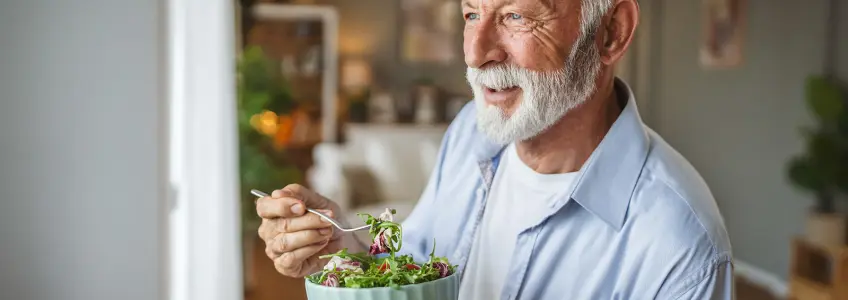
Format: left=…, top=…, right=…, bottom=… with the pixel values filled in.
left=308, top=124, right=447, bottom=243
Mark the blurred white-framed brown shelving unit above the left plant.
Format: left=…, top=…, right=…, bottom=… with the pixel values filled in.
left=245, top=3, right=339, bottom=144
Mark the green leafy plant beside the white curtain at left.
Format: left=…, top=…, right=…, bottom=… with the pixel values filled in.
left=237, top=46, right=302, bottom=289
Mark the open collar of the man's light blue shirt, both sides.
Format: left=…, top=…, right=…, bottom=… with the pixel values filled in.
left=475, top=78, right=650, bottom=230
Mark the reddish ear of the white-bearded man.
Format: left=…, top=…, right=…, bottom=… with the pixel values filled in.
left=598, top=0, right=639, bottom=65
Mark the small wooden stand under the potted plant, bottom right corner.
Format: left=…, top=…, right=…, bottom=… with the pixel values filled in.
left=789, top=238, right=848, bottom=300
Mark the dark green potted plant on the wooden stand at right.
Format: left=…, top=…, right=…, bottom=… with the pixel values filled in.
left=788, top=76, right=848, bottom=246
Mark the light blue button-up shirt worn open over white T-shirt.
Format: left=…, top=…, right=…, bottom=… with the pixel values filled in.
left=402, top=80, right=735, bottom=300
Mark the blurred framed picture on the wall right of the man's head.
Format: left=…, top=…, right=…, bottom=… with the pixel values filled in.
left=700, top=0, right=745, bottom=69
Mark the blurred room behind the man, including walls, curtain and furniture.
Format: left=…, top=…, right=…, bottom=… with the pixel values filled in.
left=0, top=0, right=848, bottom=300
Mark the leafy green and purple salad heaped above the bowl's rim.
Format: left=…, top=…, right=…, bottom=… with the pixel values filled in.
left=307, top=209, right=456, bottom=288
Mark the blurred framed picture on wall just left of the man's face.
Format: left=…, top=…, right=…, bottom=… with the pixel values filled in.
left=400, top=0, right=462, bottom=64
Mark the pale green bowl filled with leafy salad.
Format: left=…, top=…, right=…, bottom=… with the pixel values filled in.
left=306, top=209, right=459, bottom=300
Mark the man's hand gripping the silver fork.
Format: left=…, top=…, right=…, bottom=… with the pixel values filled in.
left=256, top=184, right=363, bottom=277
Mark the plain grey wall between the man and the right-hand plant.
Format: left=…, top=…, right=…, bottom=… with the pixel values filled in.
left=648, top=0, right=848, bottom=278
